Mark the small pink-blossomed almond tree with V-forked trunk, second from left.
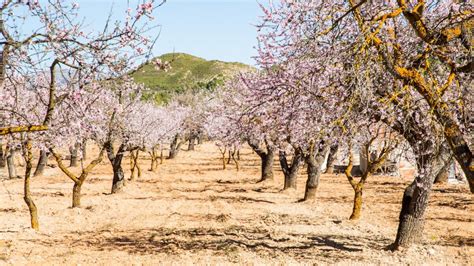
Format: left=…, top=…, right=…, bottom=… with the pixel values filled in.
left=44, top=83, right=110, bottom=208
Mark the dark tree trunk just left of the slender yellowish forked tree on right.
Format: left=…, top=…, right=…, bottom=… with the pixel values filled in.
left=303, top=143, right=329, bottom=201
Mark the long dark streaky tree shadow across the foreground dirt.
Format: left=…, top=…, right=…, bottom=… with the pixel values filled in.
left=32, top=226, right=389, bottom=261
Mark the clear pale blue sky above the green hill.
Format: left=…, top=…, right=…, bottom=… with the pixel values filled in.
left=78, top=0, right=261, bottom=65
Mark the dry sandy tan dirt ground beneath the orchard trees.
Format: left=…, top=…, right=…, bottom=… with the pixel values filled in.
left=0, top=143, right=474, bottom=265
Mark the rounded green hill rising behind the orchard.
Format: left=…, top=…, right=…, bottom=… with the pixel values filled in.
left=132, top=53, right=252, bottom=102
